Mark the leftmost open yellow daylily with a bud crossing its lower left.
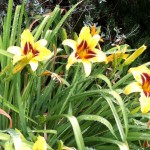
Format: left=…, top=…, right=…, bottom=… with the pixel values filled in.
left=8, top=29, right=51, bottom=72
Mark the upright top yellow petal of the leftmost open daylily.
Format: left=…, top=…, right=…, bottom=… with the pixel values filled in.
left=21, top=29, right=34, bottom=49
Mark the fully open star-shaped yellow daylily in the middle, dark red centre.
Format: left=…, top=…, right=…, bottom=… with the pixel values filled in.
left=62, top=26, right=107, bottom=76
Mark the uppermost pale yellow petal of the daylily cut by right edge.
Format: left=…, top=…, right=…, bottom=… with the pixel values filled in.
left=129, top=66, right=150, bottom=84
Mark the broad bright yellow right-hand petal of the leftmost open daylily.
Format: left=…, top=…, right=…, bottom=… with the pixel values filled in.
left=34, top=46, right=51, bottom=61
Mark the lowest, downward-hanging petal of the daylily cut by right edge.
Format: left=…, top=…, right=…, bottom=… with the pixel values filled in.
left=139, top=93, right=150, bottom=114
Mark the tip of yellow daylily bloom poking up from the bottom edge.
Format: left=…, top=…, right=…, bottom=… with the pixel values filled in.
left=32, top=136, right=47, bottom=150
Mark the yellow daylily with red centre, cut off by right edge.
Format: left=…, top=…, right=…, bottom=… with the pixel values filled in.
left=125, top=66, right=150, bottom=113
